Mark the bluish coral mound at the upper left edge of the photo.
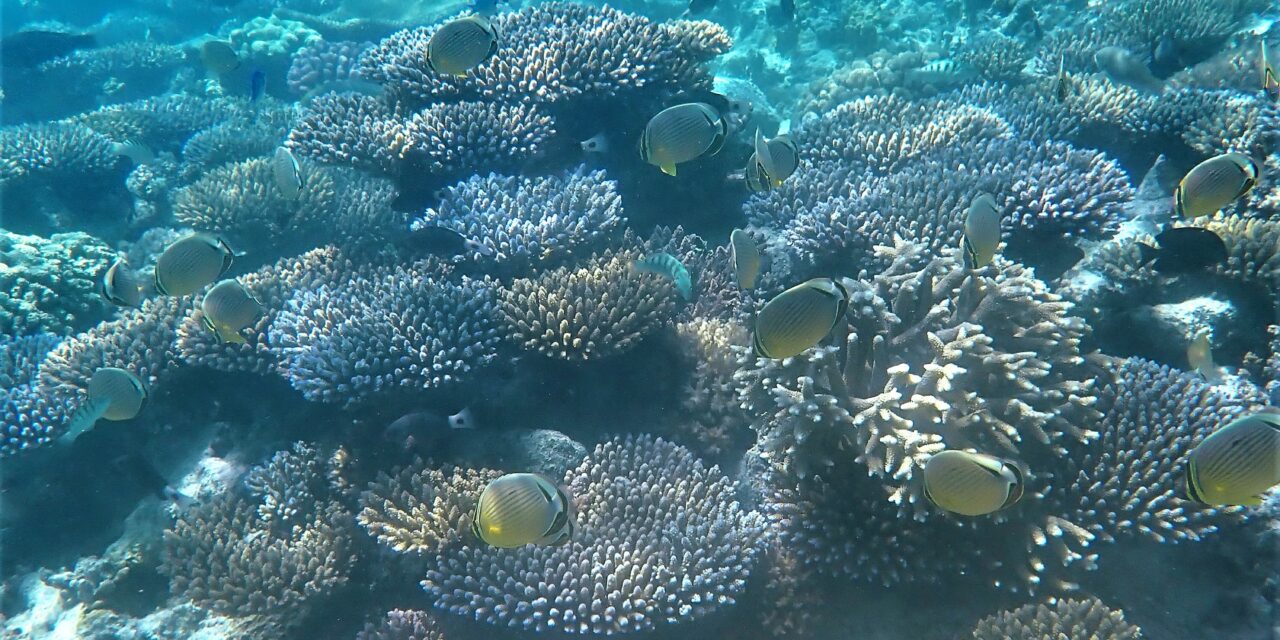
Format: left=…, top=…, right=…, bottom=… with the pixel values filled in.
left=0, top=123, right=118, bottom=191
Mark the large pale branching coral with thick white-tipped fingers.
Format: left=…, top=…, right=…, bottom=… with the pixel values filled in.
left=735, top=247, right=1098, bottom=504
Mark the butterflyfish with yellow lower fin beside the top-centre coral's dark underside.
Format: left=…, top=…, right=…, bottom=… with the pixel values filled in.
left=640, top=102, right=728, bottom=175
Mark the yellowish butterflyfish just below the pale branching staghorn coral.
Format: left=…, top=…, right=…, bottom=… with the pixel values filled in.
left=924, top=449, right=1023, bottom=516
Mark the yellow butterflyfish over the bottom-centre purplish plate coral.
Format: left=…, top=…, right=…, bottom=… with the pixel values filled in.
left=471, top=474, right=577, bottom=549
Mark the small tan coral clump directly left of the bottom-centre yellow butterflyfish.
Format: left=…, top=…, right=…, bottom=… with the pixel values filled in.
left=356, top=460, right=502, bottom=558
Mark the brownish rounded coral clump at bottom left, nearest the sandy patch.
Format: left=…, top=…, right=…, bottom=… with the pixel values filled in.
left=161, top=444, right=352, bottom=628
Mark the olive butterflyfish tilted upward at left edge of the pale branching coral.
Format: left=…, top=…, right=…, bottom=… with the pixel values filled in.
left=753, top=278, right=849, bottom=360
